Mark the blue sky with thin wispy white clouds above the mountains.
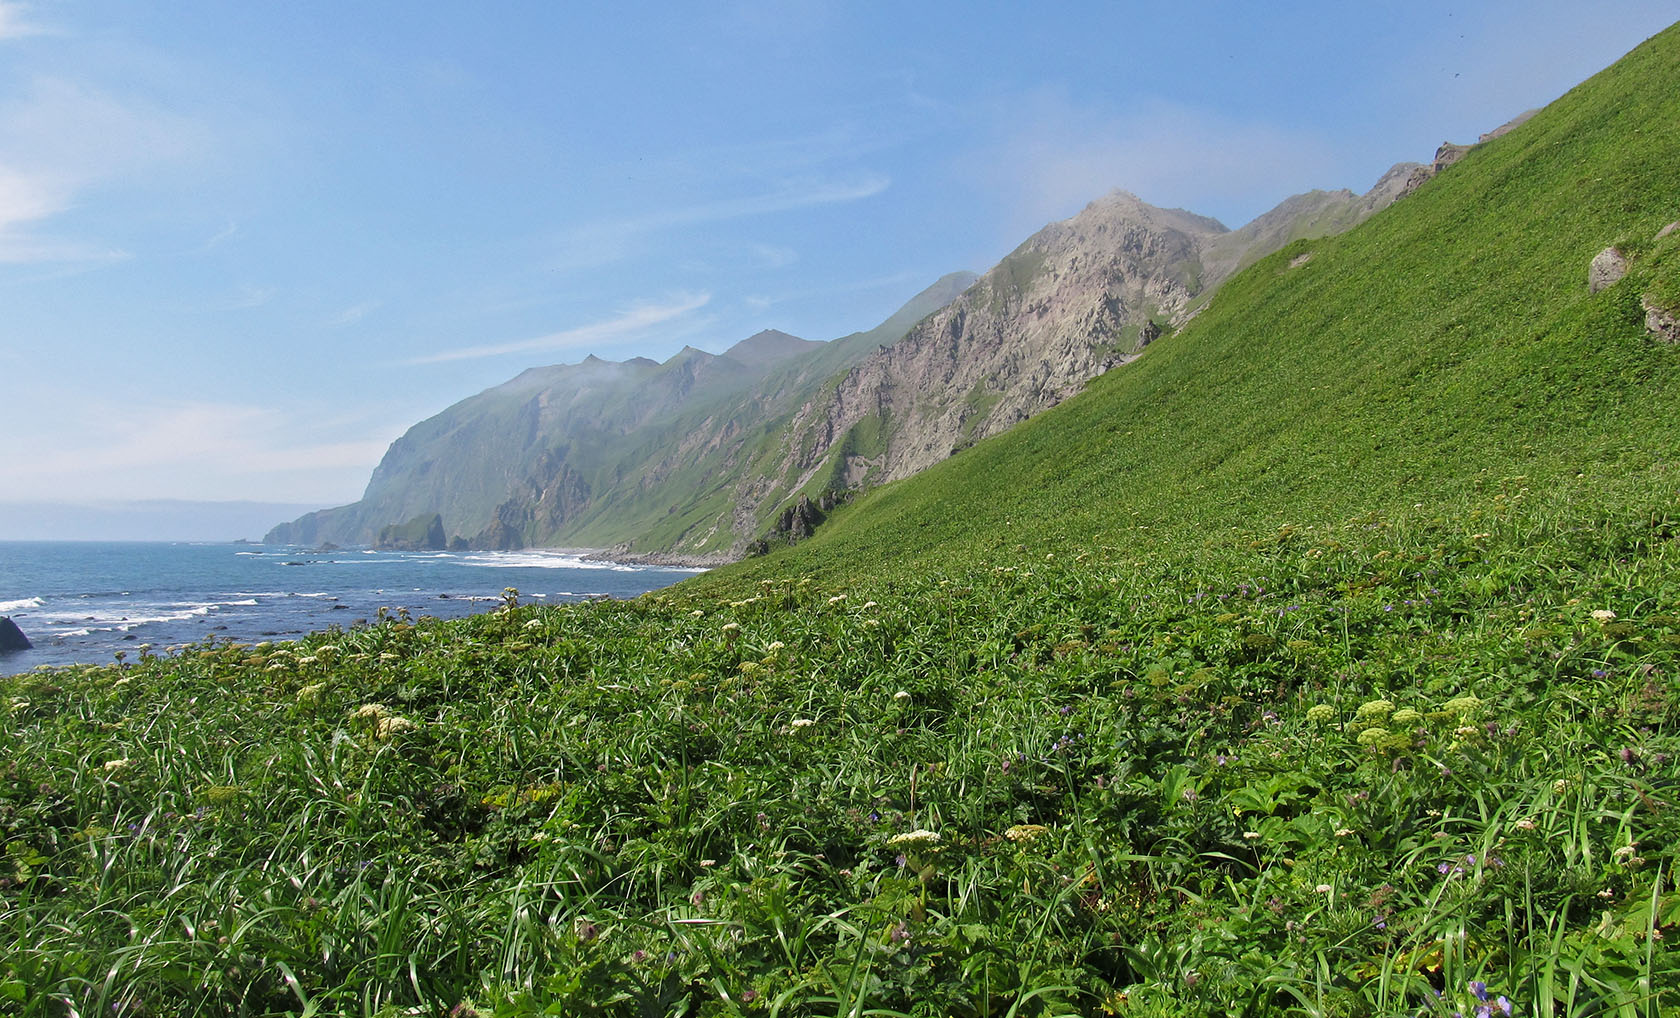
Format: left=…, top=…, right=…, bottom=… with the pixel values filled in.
left=0, top=0, right=1680, bottom=517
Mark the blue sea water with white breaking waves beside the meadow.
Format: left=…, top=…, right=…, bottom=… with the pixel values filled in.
left=0, top=541, right=696, bottom=674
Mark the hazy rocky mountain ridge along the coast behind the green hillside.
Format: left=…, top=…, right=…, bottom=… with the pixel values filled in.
left=267, top=163, right=1420, bottom=564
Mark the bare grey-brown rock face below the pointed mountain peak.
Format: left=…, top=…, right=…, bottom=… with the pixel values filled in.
left=769, top=192, right=1228, bottom=487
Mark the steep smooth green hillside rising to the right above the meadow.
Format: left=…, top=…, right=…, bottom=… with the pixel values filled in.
left=711, top=23, right=1680, bottom=594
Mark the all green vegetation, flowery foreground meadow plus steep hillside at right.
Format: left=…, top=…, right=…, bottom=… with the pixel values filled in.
left=0, top=21, right=1680, bottom=1018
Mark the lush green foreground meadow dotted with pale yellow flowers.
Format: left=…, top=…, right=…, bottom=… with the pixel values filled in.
left=0, top=507, right=1680, bottom=1016
